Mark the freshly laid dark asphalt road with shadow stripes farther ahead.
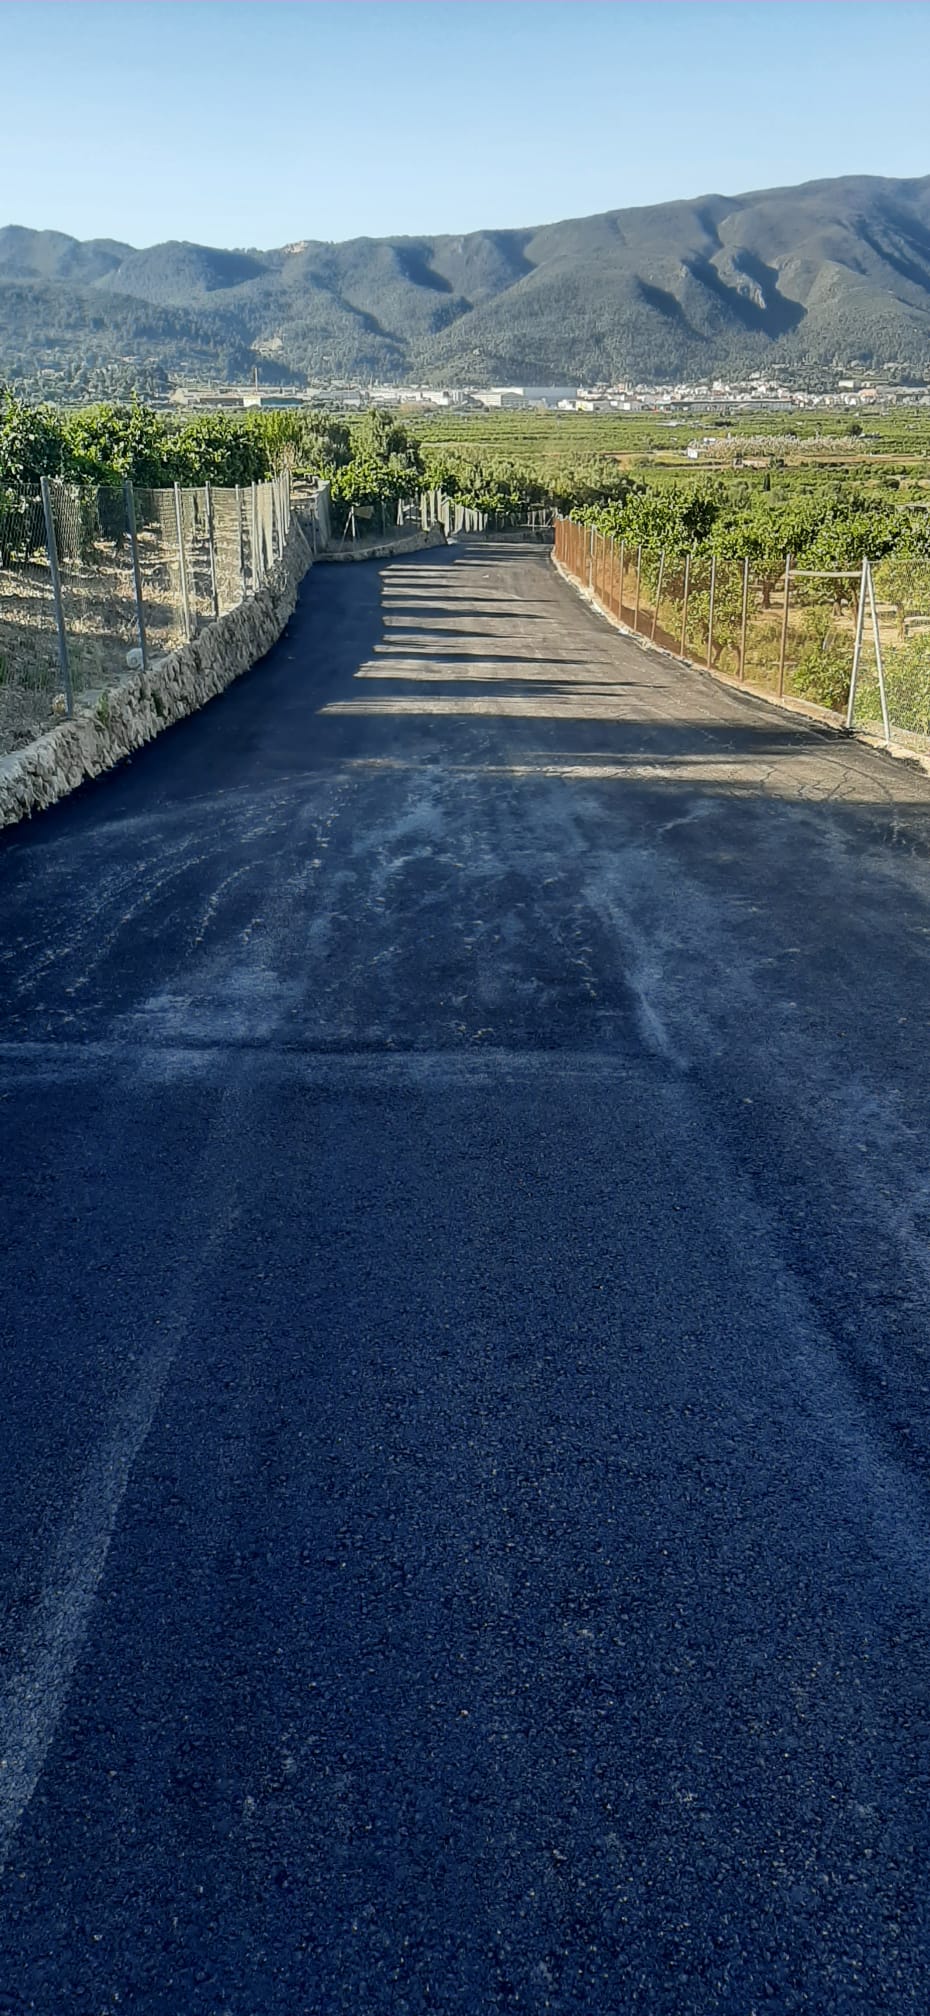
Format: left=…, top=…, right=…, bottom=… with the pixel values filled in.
left=0, top=544, right=930, bottom=2016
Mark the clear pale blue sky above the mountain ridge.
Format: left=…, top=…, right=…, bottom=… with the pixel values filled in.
left=0, top=0, right=930, bottom=246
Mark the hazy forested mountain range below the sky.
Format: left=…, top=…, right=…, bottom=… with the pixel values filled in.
left=0, top=175, right=930, bottom=387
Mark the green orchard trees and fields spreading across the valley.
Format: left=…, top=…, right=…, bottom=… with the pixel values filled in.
left=0, top=393, right=930, bottom=734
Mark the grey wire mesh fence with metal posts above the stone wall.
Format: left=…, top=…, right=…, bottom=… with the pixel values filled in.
left=0, top=476, right=290, bottom=752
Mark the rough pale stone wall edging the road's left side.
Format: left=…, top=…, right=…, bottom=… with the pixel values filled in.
left=0, top=520, right=313, bottom=827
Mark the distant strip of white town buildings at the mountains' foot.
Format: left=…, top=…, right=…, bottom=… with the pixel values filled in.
left=159, top=377, right=930, bottom=415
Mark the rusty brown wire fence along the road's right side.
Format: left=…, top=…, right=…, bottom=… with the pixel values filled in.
left=555, top=518, right=930, bottom=746
